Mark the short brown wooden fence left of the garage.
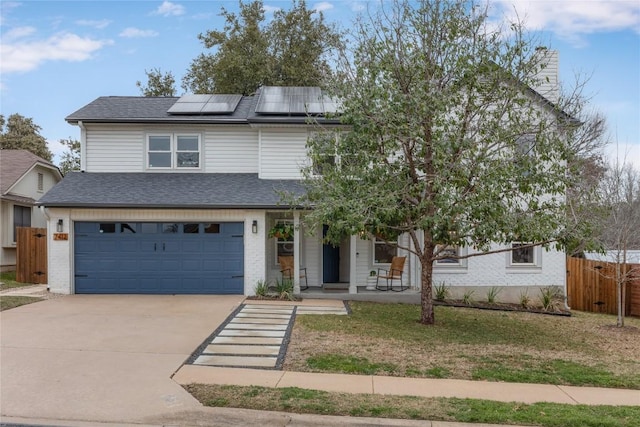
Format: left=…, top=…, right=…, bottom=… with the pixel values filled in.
left=16, top=227, right=47, bottom=283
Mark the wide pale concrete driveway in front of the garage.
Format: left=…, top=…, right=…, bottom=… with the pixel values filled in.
left=0, top=295, right=244, bottom=423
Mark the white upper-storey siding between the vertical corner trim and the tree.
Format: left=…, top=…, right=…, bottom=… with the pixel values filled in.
left=260, top=129, right=307, bottom=179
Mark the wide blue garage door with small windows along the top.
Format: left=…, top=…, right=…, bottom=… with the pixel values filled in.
left=74, top=222, right=244, bottom=294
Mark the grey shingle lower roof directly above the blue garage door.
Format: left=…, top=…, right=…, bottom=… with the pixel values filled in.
left=38, top=172, right=304, bottom=209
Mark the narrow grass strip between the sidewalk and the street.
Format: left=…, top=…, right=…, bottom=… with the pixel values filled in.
left=185, top=384, right=640, bottom=427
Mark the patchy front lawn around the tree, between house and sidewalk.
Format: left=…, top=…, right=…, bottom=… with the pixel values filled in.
left=284, top=302, right=640, bottom=389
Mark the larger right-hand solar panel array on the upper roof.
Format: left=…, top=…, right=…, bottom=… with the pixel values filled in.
left=256, top=86, right=338, bottom=115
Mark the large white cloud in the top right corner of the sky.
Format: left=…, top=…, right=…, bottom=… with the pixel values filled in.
left=496, top=0, right=640, bottom=45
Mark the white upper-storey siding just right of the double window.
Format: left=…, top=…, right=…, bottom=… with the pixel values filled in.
left=204, top=126, right=258, bottom=173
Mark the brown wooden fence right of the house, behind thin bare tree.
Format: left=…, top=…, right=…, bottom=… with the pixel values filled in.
left=567, top=257, right=640, bottom=316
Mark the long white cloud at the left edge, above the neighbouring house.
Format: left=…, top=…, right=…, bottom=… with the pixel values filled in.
left=0, top=33, right=113, bottom=74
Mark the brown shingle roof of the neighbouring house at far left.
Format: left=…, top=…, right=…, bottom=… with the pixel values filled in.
left=0, top=149, right=62, bottom=203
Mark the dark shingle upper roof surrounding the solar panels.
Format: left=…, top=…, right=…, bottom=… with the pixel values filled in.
left=65, top=87, right=340, bottom=124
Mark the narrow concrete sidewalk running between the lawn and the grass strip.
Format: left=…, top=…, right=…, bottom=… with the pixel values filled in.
left=173, top=365, right=640, bottom=406
